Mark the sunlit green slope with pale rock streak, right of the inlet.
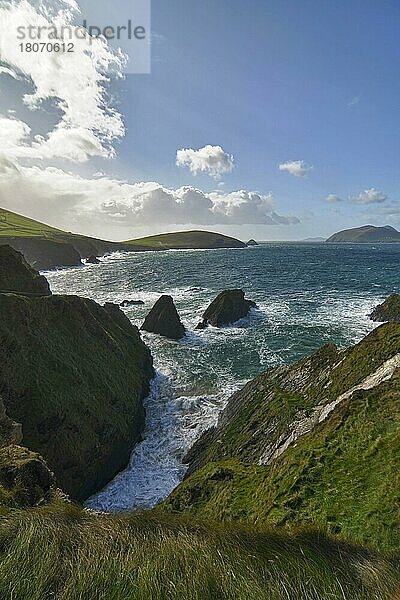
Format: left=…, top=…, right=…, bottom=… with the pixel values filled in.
left=164, top=324, right=400, bottom=550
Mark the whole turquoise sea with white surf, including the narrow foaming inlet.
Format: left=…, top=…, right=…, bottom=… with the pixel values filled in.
left=46, top=243, right=400, bottom=511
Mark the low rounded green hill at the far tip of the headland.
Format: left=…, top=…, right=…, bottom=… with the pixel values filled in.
left=125, top=231, right=246, bottom=250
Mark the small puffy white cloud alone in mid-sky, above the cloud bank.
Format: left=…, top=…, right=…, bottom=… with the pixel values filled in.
left=176, top=145, right=234, bottom=179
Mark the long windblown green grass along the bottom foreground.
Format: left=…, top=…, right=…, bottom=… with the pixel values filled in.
left=0, top=505, right=400, bottom=600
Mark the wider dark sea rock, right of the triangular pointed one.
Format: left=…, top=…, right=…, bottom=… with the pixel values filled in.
left=196, top=290, right=257, bottom=329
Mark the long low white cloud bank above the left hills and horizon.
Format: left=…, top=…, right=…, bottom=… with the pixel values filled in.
left=0, top=160, right=298, bottom=233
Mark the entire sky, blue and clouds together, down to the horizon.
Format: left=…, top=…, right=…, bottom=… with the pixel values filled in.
left=0, top=0, right=400, bottom=240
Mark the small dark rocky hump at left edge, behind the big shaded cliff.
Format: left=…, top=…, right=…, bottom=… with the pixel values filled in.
left=0, top=245, right=51, bottom=296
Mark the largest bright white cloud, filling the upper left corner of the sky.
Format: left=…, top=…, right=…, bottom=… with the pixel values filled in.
left=0, top=0, right=124, bottom=161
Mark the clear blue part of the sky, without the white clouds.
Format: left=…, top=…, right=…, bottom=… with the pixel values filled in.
left=0, top=0, right=400, bottom=239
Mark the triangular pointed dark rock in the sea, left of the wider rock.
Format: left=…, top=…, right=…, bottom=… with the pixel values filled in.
left=141, top=295, right=185, bottom=340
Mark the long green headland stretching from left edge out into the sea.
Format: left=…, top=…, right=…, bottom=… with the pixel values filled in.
left=0, top=208, right=246, bottom=270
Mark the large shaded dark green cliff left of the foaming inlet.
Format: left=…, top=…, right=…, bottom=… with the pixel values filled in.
left=0, top=294, right=153, bottom=501
